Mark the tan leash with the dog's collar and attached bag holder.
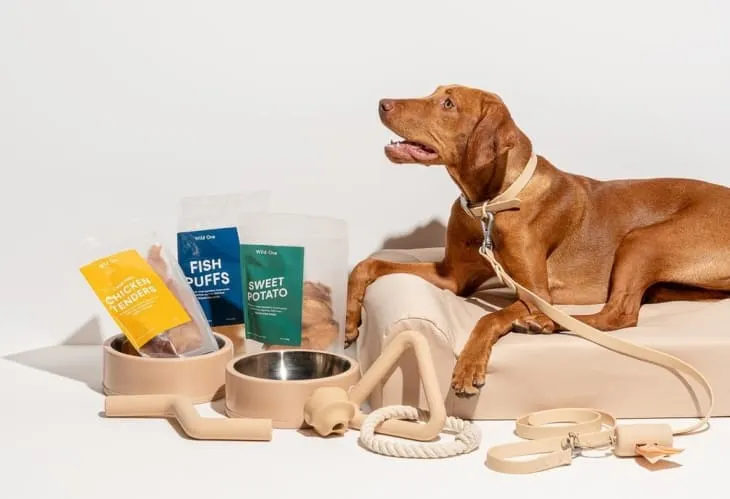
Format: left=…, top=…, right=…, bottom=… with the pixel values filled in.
left=461, top=154, right=715, bottom=474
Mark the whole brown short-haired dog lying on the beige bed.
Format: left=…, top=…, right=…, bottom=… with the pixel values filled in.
left=346, top=86, right=730, bottom=397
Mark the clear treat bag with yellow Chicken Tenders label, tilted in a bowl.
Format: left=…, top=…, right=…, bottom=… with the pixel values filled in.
left=80, top=235, right=218, bottom=357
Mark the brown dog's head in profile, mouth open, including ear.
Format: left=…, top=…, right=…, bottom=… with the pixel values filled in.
left=378, top=85, right=514, bottom=169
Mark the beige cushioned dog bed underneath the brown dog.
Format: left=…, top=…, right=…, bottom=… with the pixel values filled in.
left=357, top=248, right=730, bottom=419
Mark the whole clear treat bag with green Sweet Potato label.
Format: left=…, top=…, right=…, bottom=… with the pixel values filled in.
left=238, top=213, right=348, bottom=353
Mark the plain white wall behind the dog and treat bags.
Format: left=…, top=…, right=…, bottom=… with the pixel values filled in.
left=0, top=0, right=730, bottom=353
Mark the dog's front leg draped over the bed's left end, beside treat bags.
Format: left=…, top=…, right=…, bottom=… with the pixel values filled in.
left=345, top=252, right=493, bottom=346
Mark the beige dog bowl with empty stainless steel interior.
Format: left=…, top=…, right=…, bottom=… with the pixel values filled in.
left=225, top=349, right=360, bottom=429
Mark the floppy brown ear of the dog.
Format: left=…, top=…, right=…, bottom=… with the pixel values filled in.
left=464, top=103, right=515, bottom=168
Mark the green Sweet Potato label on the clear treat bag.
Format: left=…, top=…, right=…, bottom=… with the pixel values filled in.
left=241, top=244, right=304, bottom=347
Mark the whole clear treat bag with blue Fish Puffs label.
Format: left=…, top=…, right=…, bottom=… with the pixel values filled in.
left=177, top=191, right=269, bottom=354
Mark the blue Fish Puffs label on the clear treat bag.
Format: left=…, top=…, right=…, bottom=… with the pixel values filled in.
left=177, top=227, right=244, bottom=327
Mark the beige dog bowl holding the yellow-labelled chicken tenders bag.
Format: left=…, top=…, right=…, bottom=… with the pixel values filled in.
left=103, top=334, right=233, bottom=404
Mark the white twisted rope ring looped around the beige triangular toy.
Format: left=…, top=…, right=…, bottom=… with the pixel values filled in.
left=359, top=405, right=482, bottom=459
